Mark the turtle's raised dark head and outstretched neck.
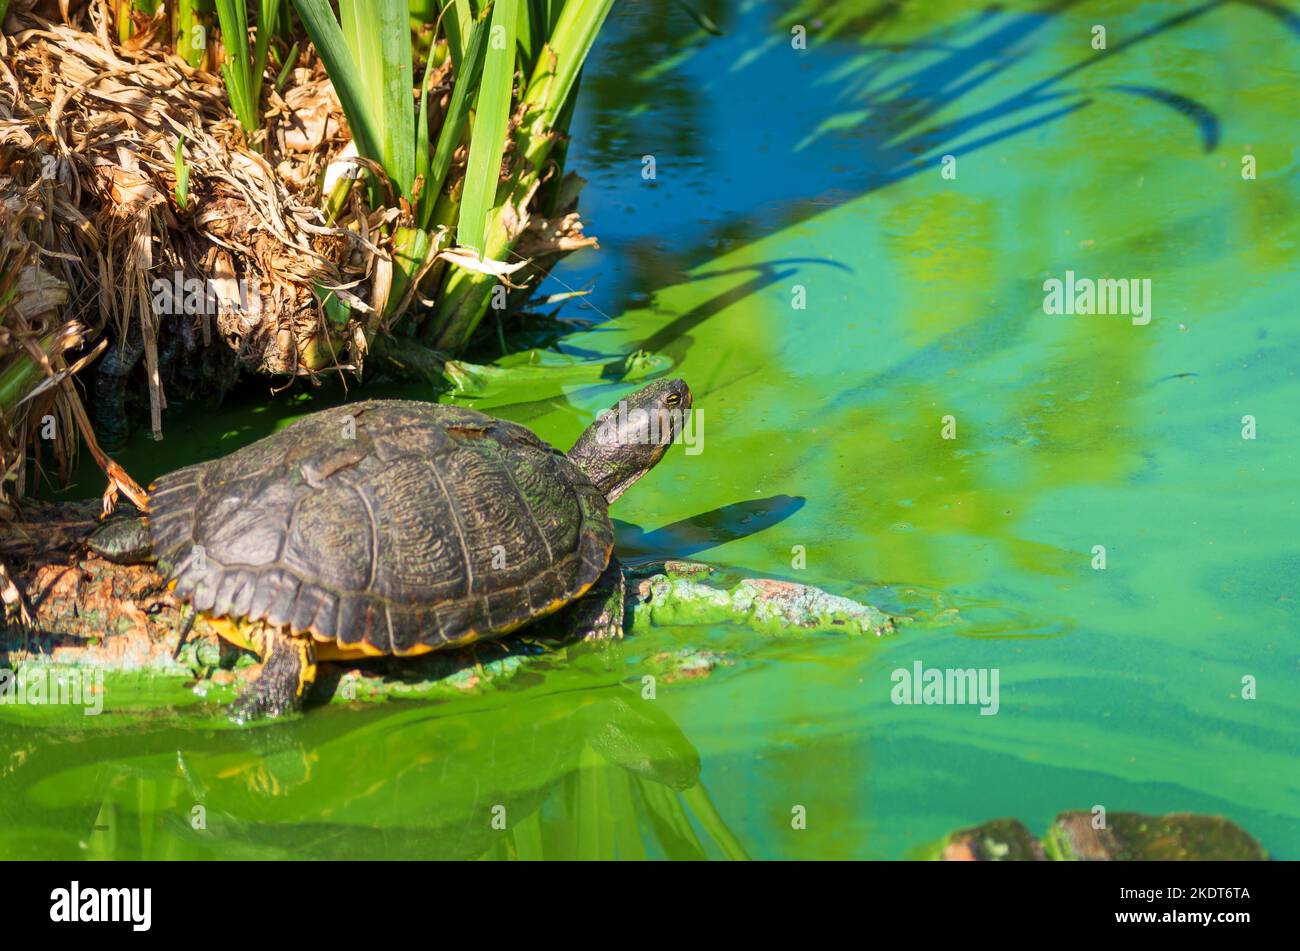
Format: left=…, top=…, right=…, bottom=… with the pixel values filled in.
left=568, top=379, right=690, bottom=503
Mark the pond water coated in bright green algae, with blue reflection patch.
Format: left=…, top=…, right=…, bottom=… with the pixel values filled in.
left=0, top=1, right=1300, bottom=859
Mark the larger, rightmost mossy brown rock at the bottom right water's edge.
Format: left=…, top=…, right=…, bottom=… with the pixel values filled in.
left=1044, top=812, right=1269, bottom=861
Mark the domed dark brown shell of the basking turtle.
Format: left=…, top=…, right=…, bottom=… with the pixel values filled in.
left=148, top=400, right=614, bottom=655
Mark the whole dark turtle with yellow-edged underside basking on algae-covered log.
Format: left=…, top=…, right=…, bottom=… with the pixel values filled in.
left=87, top=379, right=692, bottom=722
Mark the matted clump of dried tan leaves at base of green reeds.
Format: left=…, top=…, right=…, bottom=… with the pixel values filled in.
left=0, top=4, right=364, bottom=441
